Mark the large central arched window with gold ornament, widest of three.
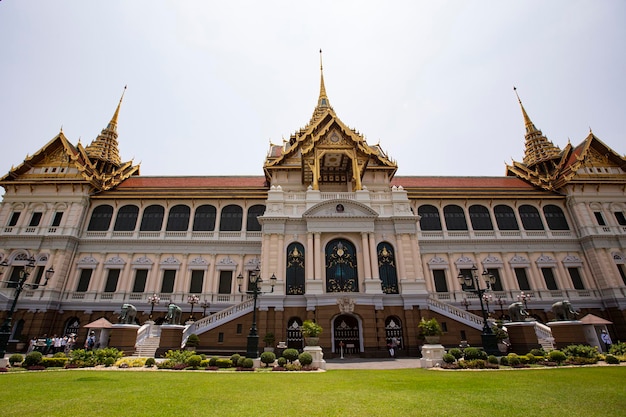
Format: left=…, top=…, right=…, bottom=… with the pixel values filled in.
left=326, top=239, right=359, bottom=292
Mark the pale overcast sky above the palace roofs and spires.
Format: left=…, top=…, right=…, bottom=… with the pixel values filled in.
left=0, top=0, right=626, bottom=182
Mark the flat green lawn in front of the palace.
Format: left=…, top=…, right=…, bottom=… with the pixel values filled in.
left=0, top=366, right=626, bottom=417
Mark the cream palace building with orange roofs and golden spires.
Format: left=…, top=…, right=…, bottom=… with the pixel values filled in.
left=0, top=63, right=626, bottom=357
